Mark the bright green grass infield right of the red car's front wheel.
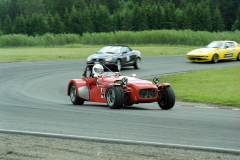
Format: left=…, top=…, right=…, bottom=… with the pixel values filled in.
left=160, top=66, right=240, bottom=107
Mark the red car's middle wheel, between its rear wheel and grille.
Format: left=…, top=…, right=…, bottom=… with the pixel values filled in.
left=106, top=86, right=124, bottom=109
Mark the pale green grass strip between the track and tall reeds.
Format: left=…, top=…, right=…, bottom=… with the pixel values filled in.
left=0, top=44, right=197, bottom=61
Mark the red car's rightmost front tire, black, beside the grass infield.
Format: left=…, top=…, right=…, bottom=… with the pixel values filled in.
left=158, top=86, right=175, bottom=110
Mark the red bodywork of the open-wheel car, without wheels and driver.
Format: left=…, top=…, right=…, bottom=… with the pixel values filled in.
left=67, top=74, right=169, bottom=105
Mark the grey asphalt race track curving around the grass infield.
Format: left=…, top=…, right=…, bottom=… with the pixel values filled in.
left=0, top=55, right=240, bottom=150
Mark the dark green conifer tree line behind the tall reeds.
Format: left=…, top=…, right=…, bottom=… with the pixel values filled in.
left=0, top=0, right=240, bottom=36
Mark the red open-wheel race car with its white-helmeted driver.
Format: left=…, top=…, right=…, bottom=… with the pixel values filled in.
left=67, top=64, right=175, bottom=110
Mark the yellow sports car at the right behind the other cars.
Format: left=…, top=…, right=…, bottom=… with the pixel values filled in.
left=186, top=41, right=240, bottom=63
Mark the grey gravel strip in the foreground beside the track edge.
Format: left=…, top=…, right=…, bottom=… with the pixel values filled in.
left=0, top=131, right=240, bottom=160
